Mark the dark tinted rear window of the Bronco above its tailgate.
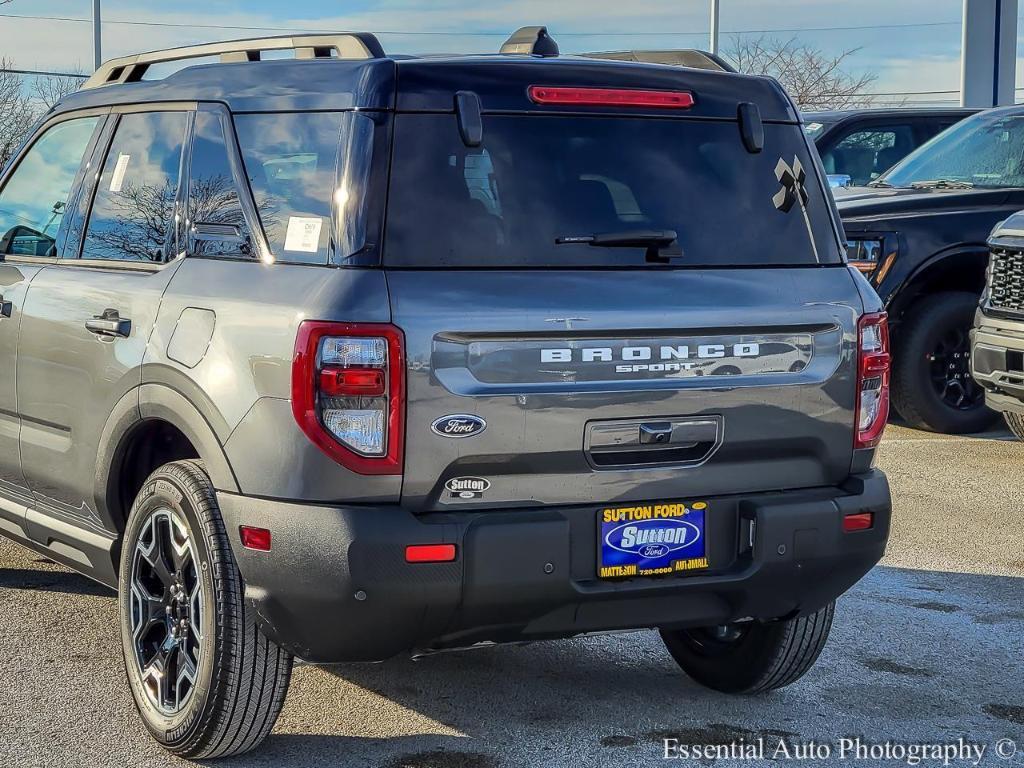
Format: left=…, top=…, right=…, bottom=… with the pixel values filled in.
left=384, top=115, right=841, bottom=267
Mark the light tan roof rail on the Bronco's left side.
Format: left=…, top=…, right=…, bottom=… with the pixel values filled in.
left=82, top=32, right=385, bottom=89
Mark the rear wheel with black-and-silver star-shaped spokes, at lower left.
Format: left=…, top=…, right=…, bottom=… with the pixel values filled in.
left=118, top=461, right=292, bottom=759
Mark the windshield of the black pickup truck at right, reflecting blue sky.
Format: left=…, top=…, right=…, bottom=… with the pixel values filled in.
left=874, top=113, right=1024, bottom=187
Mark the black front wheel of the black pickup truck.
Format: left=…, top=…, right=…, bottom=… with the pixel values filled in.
left=892, top=292, right=998, bottom=434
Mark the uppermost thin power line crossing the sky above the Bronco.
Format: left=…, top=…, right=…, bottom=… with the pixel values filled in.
left=0, top=13, right=961, bottom=37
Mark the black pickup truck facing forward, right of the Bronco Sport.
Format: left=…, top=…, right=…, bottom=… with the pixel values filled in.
left=834, top=106, right=1024, bottom=433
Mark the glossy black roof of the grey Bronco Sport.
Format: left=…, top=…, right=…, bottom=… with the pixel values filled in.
left=49, top=33, right=798, bottom=122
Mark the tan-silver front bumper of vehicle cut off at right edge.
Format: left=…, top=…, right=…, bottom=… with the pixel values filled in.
left=971, top=312, right=1024, bottom=415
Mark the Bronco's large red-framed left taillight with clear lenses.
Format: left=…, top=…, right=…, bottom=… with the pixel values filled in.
left=292, top=321, right=406, bottom=475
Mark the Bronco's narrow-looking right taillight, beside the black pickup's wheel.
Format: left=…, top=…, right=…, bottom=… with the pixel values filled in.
left=853, top=312, right=892, bottom=449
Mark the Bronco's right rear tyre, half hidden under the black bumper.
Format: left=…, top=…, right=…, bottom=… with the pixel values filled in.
left=662, top=602, right=836, bottom=693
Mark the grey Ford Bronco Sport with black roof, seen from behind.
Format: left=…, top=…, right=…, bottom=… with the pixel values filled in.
left=0, top=28, right=891, bottom=758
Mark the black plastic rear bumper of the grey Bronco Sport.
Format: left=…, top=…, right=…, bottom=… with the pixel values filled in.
left=218, top=470, right=892, bottom=663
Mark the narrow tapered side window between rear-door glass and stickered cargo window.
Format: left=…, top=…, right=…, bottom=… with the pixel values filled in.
left=188, top=112, right=253, bottom=257
